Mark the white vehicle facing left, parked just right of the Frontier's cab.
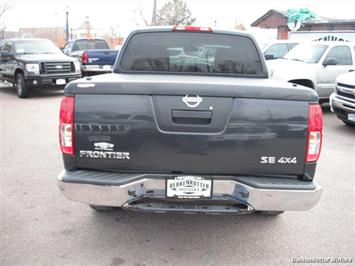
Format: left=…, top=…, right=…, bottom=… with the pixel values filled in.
left=267, top=42, right=355, bottom=102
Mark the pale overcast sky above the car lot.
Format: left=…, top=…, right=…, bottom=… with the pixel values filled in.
left=0, top=0, right=355, bottom=36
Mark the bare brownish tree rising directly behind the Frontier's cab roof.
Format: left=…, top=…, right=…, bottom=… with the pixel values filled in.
left=155, top=0, right=196, bottom=25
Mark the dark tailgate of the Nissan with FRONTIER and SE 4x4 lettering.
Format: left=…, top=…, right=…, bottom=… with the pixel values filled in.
left=74, top=90, right=308, bottom=175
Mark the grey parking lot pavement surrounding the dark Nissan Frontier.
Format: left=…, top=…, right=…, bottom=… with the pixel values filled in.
left=0, top=86, right=355, bottom=266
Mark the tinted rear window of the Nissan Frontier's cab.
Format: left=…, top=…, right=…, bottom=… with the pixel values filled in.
left=119, top=32, right=263, bottom=76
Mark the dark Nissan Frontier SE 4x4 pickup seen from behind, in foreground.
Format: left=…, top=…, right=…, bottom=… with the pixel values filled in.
left=58, top=26, right=322, bottom=215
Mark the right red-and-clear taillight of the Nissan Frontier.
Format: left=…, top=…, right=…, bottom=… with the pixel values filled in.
left=306, top=104, right=323, bottom=162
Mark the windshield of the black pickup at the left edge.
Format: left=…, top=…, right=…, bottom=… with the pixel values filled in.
left=15, top=40, right=62, bottom=54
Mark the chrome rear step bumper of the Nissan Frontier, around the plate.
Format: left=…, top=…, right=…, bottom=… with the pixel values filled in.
left=58, top=170, right=322, bottom=213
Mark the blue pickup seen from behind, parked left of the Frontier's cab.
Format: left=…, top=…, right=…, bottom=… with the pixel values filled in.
left=63, top=39, right=118, bottom=76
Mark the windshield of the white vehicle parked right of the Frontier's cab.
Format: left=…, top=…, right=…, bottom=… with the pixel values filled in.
left=284, top=43, right=328, bottom=64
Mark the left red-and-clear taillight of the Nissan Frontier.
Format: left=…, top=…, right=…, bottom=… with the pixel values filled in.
left=59, top=96, right=74, bottom=155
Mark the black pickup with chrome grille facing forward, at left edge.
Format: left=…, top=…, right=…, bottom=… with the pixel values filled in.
left=0, top=39, right=81, bottom=98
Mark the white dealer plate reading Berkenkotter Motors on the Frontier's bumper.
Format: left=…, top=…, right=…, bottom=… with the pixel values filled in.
left=166, top=176, right=212, bottom=199
